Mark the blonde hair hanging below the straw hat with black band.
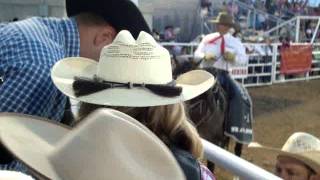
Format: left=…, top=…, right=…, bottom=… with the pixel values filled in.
left=79, top=103, right=203, bottom=158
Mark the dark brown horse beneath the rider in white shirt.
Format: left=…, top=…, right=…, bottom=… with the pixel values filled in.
left=173, top=58, right=242, bottom=169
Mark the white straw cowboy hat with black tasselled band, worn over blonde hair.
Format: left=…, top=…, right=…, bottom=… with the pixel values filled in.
left=51, top=30, right=215, bottom=107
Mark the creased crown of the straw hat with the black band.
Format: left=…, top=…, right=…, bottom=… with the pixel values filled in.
left=97, top=31, right=172, bottom=84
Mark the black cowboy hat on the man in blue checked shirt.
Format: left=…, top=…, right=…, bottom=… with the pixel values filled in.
left=66, top=0, right=151, bottom=38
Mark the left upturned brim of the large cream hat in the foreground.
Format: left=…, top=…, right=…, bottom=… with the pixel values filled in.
left=0, top=113, right=69, bottom=179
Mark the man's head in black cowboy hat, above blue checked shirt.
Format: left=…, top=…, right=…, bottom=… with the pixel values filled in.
left=66, top=0, right=151, bottom=60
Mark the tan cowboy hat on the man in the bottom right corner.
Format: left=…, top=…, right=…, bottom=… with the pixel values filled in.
left=249, top=132, right=320, bottom=174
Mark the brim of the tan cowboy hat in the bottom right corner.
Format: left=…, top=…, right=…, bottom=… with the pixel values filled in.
left=249, top=143, right=320, bottom=174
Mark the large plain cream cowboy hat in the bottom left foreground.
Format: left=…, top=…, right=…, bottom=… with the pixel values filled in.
left=0, top=109, right=185, bottom=180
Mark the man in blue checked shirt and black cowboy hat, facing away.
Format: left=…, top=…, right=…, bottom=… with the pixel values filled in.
left=0, top=0, right=150, bottom=171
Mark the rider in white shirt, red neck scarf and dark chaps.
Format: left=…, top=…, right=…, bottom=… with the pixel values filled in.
left=195, top=13, right=252, bottom=150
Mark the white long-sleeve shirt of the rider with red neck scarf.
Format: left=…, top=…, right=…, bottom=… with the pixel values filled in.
left=194, top=32, right=248, bottom=71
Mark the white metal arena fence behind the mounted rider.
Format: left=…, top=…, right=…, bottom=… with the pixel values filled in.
left=161, top=43, right=320, bottom=87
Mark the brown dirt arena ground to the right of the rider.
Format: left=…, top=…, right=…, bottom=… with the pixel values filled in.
left=216, top=80, right=320, bottom=180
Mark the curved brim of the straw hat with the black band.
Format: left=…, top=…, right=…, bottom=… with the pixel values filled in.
left=51, top=57, right=215, bottom=107
